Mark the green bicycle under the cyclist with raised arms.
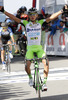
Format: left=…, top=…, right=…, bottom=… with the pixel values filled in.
left=26, top=53, right=47, bottom=100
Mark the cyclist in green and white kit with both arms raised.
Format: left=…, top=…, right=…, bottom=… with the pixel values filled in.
left=0, top=6, right=66, bottom=90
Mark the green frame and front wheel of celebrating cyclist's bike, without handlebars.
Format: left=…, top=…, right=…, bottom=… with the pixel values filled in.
left=33, top=57, right=42, bottom=100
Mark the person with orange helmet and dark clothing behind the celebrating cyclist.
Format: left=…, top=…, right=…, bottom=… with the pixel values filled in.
left=15, top=14, right=28, bottom=56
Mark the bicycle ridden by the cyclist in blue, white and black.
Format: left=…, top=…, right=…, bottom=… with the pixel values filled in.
left=2, top=44, right=13, bottom=73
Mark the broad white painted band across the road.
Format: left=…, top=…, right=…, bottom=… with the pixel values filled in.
left=0, top=67, right=68, bottom=84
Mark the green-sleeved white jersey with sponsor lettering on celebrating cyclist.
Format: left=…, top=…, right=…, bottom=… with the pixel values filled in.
left=21, top=19, right=46, bottom=46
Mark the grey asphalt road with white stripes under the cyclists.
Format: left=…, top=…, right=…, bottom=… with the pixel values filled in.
left=0, top=56, right=68, bottom=100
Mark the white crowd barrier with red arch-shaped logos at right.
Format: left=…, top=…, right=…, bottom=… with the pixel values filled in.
left=44, top=30, right=68, bottom=56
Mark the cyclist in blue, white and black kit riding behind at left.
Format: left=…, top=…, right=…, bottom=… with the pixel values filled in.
left=0, top=22, right=14, bottom=70
